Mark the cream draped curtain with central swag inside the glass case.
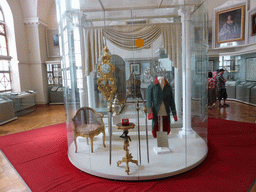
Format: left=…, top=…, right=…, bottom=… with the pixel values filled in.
left=84, top=23, right=181, bottom=75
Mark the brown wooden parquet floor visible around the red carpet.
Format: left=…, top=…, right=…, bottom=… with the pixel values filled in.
left=0, top=101, right=256, bottom=192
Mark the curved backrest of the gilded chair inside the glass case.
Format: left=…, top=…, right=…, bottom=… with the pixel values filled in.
left=72, top=107, right=104, bottom=127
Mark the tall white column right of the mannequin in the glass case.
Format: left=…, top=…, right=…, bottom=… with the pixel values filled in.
left=179, top=6, right=196, bottom=137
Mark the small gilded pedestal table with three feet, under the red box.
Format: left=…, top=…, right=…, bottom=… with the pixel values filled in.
left=116, top=123, right=138, bottom=175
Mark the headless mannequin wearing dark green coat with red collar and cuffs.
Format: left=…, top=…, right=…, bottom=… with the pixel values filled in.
left=147, top=76, right=177, bottom=138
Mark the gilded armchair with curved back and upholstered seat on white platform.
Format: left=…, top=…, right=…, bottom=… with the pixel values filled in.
left=72, top=107, right=106, bottom=153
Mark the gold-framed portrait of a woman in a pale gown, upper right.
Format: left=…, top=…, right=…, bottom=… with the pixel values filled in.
left=216, top=5, right=245, bottom=43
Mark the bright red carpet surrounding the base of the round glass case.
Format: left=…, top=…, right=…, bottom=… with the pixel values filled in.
left=0, top=119, right=256, bottom=192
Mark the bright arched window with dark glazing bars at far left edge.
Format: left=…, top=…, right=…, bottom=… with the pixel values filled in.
left=0, top=8, right=11, bottom=92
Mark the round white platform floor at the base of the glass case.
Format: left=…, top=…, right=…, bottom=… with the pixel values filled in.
left=68, top=132, right=208, bottom=180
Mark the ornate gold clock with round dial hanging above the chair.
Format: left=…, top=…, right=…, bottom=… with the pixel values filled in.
left=97, top=47, right=117, bottom=102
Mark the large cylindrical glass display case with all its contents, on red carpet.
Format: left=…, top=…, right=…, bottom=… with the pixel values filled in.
left=56, top=0, right=208, bottom=180
